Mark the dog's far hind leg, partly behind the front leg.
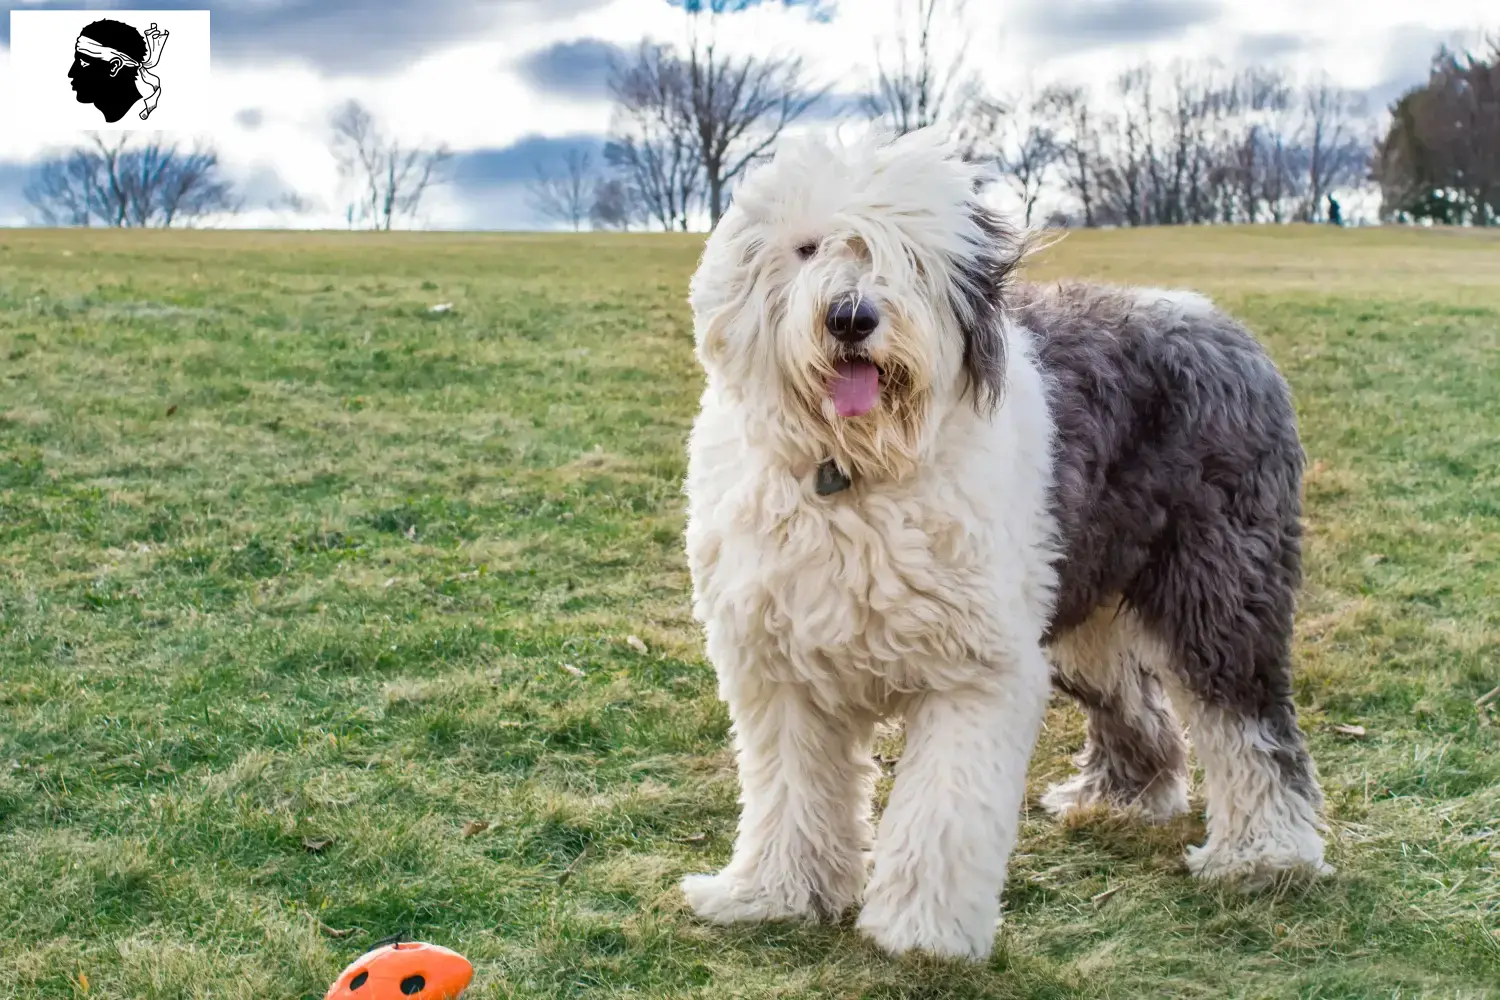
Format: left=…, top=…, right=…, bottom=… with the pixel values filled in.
left=1041, top=604, right=1188, bottom=823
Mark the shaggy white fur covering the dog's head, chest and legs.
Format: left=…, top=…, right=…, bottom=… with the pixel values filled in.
left=683, top=133, right=1322, bottom=958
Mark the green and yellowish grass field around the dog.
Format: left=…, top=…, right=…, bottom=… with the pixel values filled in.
left=0, top=228, right=1500, bottom=1000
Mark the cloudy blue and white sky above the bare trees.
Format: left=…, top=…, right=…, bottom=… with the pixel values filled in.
left=0, top=0, right=1500, bottom=229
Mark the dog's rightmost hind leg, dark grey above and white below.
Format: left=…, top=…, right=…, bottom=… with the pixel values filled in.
left=1130, top=517, right=1331, bottom=886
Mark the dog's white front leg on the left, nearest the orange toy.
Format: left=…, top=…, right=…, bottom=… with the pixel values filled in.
left=683, top=684, right=876, bottom=924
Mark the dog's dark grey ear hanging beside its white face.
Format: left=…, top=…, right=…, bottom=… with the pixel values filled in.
left=950, top=205, right=1025, bottom=412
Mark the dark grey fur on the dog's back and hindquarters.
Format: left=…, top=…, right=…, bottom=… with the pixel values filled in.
left=1011, top=282, right=1322, bottom=827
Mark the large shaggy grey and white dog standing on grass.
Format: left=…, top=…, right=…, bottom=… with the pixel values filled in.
left=683, top=132, right=1325, bottom=958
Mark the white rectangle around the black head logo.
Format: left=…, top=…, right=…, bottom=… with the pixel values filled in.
left=0, top=10, right=218, bottom=138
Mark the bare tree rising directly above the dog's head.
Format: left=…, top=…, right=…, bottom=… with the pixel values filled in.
left=861, top=0, right=977, bottom=135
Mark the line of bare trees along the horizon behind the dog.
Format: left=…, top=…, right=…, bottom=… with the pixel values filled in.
left=14, top=0, right=1500, bottom=231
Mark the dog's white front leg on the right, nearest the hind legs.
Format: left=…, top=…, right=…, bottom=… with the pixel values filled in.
left=860, top=649, right=1049, bottom=960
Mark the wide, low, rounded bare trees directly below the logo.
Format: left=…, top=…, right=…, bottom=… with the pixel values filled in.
left=24, top=132, right=240, bottom=228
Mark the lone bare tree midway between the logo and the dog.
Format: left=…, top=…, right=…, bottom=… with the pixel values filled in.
left=333, top=100, right=452, bottom=229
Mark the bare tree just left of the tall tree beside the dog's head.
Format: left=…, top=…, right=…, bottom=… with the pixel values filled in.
left=605, top=42, right=702, bottom=232
